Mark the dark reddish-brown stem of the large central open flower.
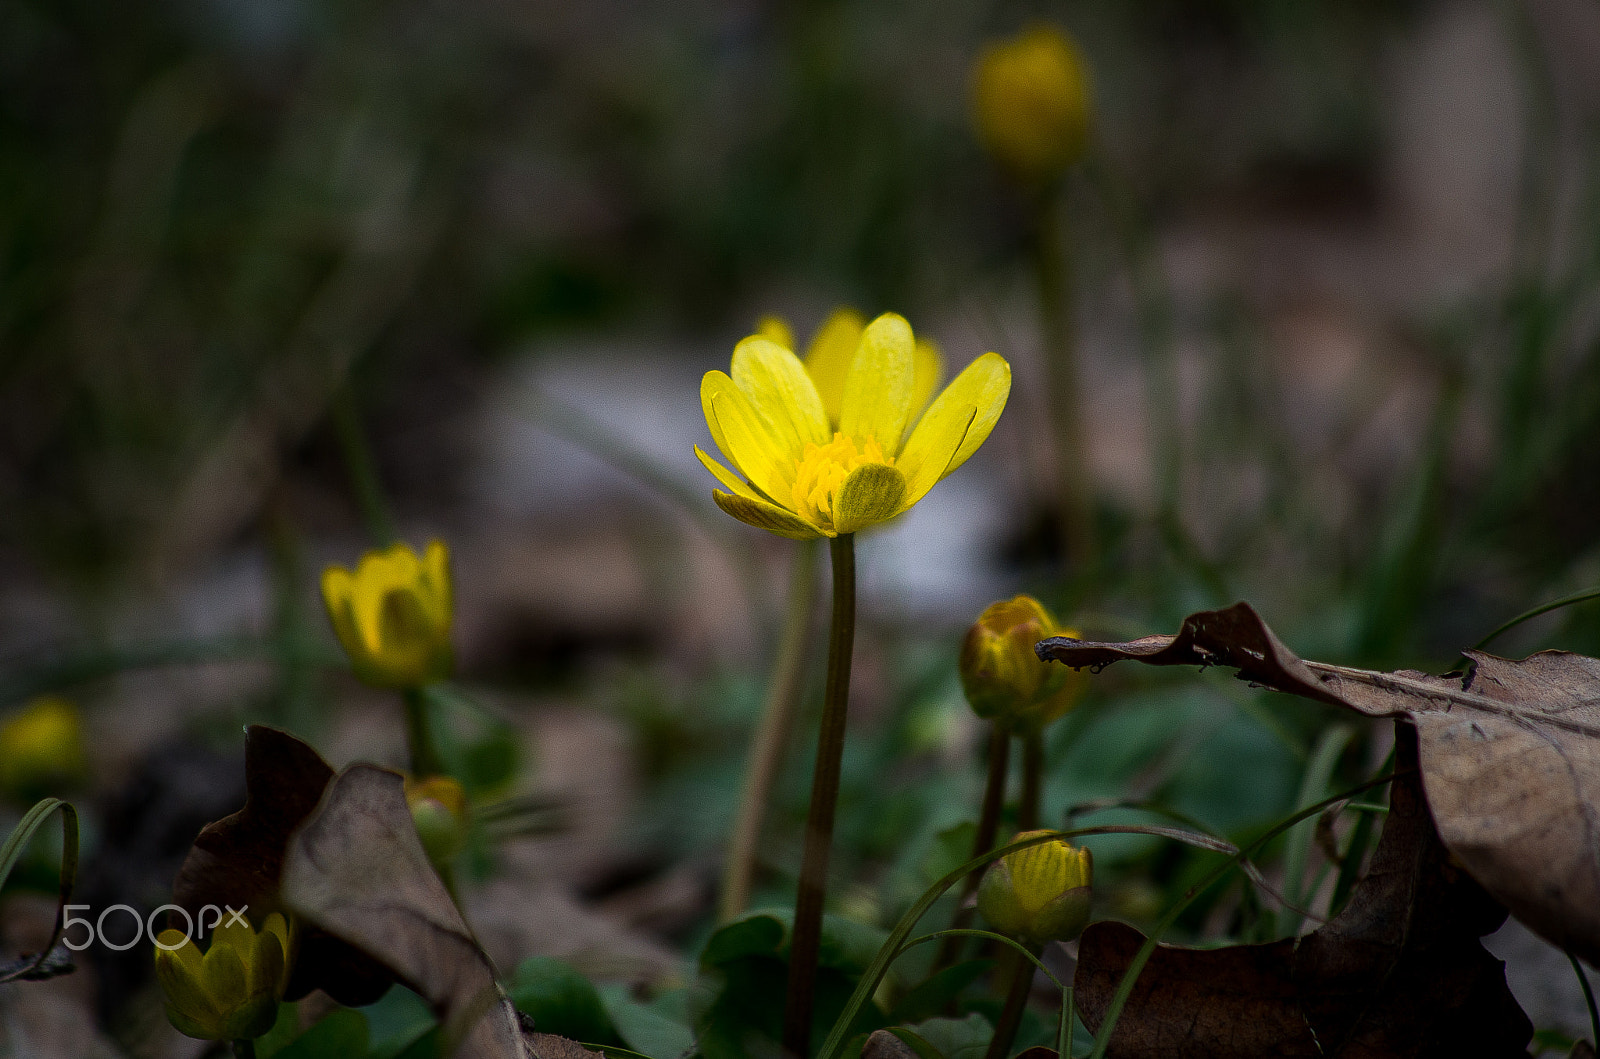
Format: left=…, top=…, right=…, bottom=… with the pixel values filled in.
left=784, top=533, right=856, bottom=1059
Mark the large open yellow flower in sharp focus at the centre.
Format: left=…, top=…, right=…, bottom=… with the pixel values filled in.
left=694, top=314, right=1011, bottom=541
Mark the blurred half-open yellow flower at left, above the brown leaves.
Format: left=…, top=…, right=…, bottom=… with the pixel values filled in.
left=322, top=541, right=451, bottom=688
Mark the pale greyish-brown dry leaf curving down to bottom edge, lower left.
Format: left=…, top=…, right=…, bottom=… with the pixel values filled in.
left=283, top=765, right=528, bottom=1059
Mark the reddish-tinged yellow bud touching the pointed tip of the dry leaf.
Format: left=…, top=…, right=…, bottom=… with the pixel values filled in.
left=960, top=595, right=1088, bottom=733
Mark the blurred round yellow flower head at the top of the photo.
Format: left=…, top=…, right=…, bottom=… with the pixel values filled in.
left=973, top=24, right=1090, bottom=181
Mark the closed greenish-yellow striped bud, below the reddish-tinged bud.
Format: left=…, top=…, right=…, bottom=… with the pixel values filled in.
left=978, top=830, right=1094, bottom=945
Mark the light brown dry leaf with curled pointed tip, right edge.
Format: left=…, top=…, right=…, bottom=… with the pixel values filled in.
left=1037, top=603, right=1600, bottom=965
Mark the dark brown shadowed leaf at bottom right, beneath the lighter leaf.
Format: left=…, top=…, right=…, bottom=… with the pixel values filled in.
left=1074, top=723, right=1533, bottom=1059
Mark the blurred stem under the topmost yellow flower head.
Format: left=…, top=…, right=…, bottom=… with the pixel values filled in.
left=1034, top=186, right=1094, bottom=569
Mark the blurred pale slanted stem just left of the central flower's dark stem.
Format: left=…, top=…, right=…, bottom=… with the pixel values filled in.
left=729, top=541, right=818, bottom=923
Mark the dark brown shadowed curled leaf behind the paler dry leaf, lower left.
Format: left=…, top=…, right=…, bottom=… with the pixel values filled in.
left=173, top=725, right=394, bottom=1008
